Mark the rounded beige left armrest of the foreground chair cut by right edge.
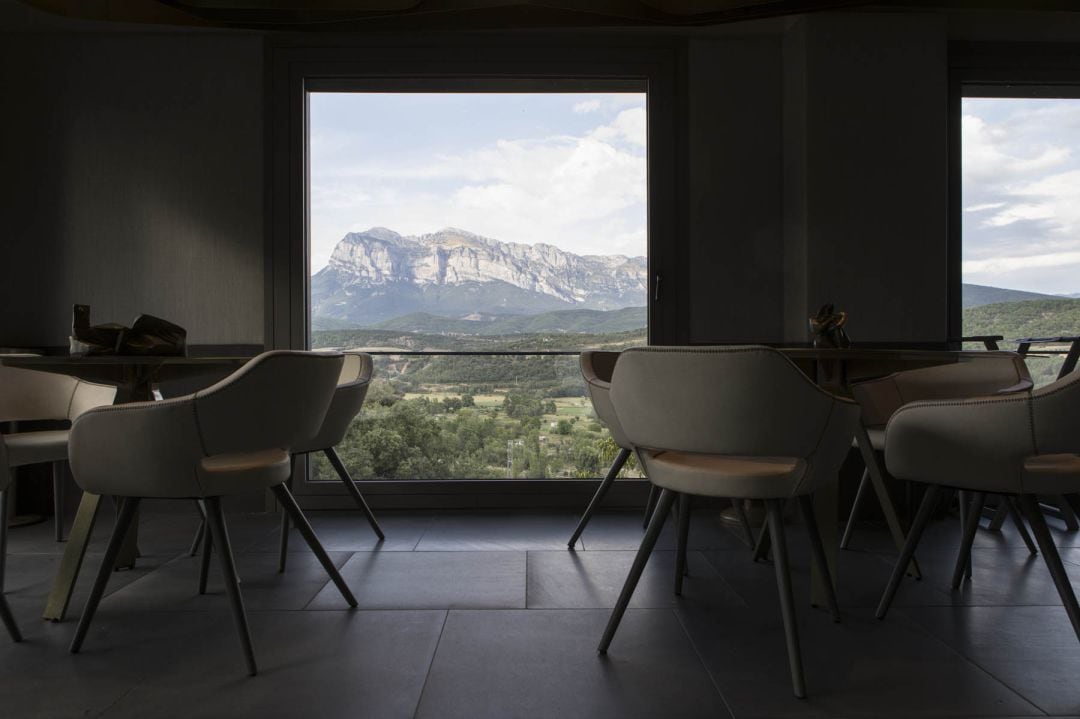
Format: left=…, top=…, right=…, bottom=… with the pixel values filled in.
left=885, top=392, right=1036, bottom=492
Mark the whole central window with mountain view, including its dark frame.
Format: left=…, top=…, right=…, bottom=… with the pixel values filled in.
left=266, top=47, right=673, bottom=500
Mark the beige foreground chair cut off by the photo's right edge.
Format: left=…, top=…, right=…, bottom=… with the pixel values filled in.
left=877, top=372, right=1080, bottom=638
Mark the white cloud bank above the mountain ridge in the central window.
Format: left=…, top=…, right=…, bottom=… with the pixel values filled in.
left=311, top=107, right=647, bottom=270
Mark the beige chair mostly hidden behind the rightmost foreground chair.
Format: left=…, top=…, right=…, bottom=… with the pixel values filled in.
left=840, top=352, right=1034, bottom=576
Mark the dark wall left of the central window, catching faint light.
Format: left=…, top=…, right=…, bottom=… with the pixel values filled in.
left=0, top=33, right=265, bottom=347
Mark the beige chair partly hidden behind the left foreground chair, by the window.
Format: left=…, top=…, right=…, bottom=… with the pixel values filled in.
left=279, top=352, right=386, bottom=571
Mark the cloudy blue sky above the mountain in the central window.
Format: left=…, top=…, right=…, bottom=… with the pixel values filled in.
left=309, top=93, right=647, bottom=273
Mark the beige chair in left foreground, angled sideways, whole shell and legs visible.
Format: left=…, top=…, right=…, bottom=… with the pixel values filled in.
left=69, top=351, right=356, bottom=675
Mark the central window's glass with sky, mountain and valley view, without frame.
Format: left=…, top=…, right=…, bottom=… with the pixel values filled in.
left=307, top=83, right=649, bottom=481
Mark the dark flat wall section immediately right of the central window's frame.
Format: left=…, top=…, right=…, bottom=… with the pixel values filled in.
left=687, top=37, right=784, bottom=342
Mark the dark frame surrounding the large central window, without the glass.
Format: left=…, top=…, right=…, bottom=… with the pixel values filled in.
left=266, top=40, right=686, bottom=508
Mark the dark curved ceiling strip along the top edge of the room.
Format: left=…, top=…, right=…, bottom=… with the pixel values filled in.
left=21, top=0, right=1080, bottom=31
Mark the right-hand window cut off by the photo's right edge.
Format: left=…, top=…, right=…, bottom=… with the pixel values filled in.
left=960, top=84, right=1080, bottom=384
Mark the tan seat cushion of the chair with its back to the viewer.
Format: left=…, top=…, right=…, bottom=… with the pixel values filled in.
left=643, top=452, right=807, bottom=499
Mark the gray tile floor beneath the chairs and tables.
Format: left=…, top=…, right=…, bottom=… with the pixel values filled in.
left=0, top=503, right=1080, bottom=719
